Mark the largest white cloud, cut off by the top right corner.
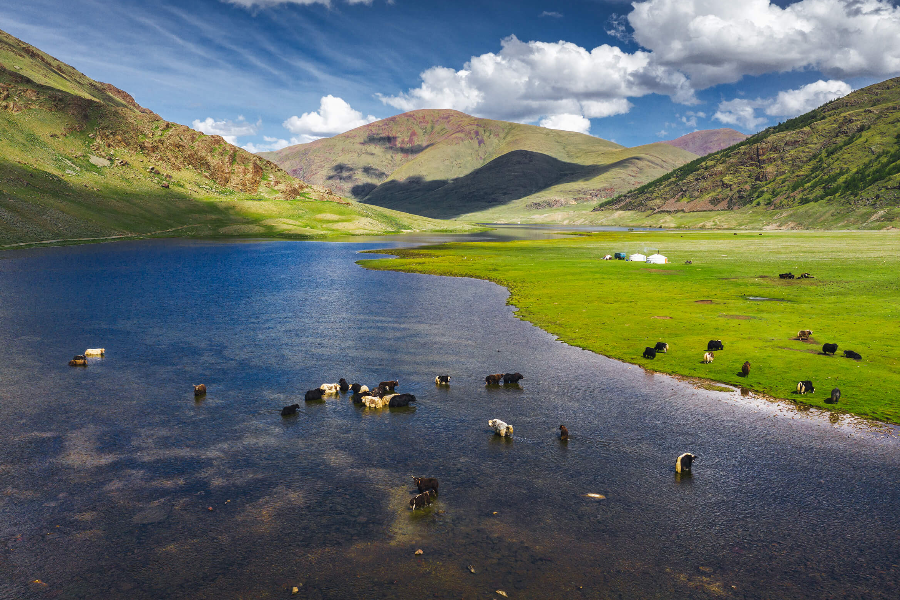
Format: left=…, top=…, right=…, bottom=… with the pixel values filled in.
left=628, top=0, right=900, bottom=89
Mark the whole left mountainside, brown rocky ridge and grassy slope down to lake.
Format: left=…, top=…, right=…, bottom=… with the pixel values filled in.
left=0, top=32, right=464, bottom=248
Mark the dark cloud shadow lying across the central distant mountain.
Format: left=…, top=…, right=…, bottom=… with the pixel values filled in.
left=351, top=150, right=642, bottom=219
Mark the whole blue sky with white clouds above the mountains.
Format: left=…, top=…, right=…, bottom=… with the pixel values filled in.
left=0, top=0, right=900, bottom=151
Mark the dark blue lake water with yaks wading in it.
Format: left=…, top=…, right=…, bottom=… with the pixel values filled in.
left=0, top=241, right=900, bottom=599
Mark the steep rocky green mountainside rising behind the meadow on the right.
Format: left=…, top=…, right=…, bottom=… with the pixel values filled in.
left=595, top=78, right=900, bottom=228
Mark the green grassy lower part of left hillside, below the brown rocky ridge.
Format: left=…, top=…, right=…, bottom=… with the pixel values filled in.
left=0, top=109, right=477, bottom=249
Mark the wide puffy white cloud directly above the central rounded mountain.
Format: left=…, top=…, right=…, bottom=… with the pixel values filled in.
left=378, top=36, right=696, bottom=122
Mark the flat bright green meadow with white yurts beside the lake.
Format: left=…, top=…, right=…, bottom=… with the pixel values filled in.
left=363, top=232, right=900, bottom=423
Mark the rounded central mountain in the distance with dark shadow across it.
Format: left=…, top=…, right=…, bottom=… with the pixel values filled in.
left=262, top=110, right=696, bottom=221
